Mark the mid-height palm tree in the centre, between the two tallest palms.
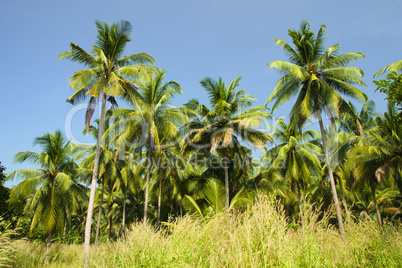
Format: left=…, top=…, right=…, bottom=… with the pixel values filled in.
left=183, top=77, right=272, bottom=210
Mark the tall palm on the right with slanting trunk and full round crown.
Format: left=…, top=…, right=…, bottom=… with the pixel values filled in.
left=266, top=21, right=367, bottom=234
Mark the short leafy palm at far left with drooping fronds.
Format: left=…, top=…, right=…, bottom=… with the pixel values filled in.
left=8, top=131, right=86, bottom=263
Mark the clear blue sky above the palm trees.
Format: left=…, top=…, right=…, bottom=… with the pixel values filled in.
left=0, top=0, right=402, bottom=186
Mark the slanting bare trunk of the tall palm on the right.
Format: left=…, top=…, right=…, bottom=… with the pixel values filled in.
left=316, top=110, right=345, bottom=236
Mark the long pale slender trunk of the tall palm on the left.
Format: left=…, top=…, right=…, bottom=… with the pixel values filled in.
left=83, top=94, right=107, bottom=267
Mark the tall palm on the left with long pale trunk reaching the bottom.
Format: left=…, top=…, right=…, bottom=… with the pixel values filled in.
left=59, top=21, right=155, bottom=266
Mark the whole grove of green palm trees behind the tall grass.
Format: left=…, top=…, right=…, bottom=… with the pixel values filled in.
left=2, top=21, right=402, bottom=265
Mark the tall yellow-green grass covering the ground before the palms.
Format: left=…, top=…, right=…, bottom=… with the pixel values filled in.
left=6, top=198, right=402, bottom=267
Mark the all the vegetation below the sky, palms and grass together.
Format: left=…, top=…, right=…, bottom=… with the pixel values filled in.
left=0, top=20, right=402, bottom=267
